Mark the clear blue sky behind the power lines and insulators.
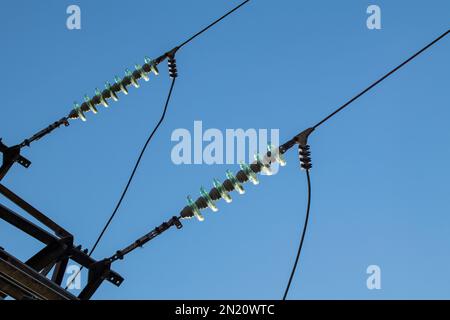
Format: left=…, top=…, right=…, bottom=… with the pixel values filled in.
left=0, top=0, right=450, bottom=299
